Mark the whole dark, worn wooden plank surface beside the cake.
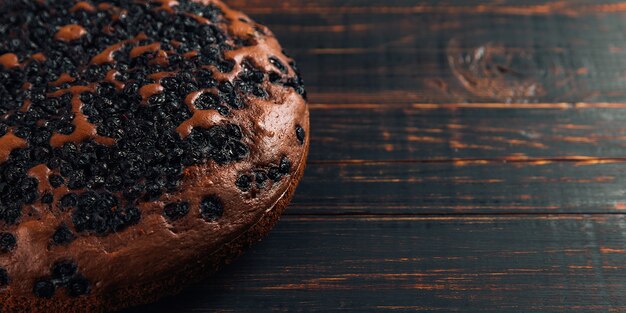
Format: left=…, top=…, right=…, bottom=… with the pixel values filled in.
left=124, top=0, right=626, bottom=313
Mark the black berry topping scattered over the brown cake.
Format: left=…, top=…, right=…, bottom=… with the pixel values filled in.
left=0, top=0, right=306, bottom=239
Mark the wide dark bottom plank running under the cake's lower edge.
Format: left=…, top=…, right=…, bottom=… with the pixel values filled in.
left=127, top=215, right=626, bottom=313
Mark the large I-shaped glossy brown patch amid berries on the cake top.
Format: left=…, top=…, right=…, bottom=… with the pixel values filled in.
left=48, top=84, right=115, bottom=148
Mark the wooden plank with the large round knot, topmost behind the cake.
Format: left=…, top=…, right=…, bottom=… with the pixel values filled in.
left=223, top=0, right=626, bottom=103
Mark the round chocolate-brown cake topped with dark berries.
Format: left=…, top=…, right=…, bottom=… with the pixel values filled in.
left=0, top=0, right=309, bottom=313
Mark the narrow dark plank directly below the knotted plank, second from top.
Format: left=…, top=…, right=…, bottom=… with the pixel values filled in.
left=309, top=103, right=626, bottom=161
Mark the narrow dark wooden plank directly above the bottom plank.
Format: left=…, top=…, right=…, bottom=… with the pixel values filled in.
left=286, top=159, right=626, bottom=215
